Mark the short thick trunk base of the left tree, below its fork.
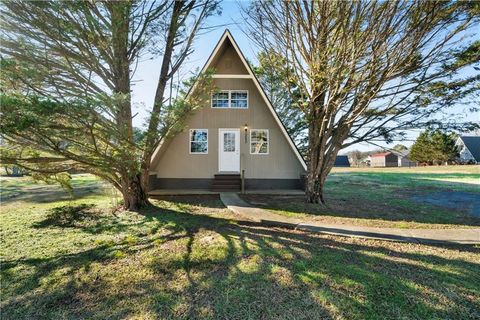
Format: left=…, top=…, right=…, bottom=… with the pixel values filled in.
left=121, top=174, right=150, bottom=211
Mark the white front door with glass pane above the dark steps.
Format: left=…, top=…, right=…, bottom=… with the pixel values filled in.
left=218, top=129, right=240, bottom=172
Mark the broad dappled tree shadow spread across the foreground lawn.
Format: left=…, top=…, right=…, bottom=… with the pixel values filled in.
left=2, top=201, right=480, bottom=319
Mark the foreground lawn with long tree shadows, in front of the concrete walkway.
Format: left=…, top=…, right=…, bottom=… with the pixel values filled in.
left=0, top=176, right=480, bottom=319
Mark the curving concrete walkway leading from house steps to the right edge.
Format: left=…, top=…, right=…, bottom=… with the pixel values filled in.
left=220, top=192, right=480, bottom=244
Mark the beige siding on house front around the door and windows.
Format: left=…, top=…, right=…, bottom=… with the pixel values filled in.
left=152, top=76, right=304, bottom=179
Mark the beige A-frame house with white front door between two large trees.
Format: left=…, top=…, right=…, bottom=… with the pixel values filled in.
left=150, top=30, right=306, bottom=191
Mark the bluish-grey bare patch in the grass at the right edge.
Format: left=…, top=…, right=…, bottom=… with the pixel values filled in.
left=410, top=191, right=480, bottom=217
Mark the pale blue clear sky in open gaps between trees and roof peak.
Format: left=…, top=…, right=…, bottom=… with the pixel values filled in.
left=129, top=0, right=480, bottom=153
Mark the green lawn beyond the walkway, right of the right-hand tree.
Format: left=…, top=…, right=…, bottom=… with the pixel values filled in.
left=243, top=166, right=480, bottom=228
